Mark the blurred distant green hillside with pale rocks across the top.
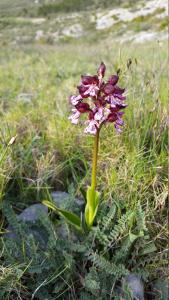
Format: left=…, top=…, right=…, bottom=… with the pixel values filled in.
left=0, top=0, right=168, bottom=45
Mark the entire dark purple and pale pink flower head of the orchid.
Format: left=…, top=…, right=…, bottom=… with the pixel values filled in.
left=69, top=62, right=127, bottom=135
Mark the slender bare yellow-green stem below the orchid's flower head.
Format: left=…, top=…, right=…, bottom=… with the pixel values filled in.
left=91, top=129, right=100, bottom=190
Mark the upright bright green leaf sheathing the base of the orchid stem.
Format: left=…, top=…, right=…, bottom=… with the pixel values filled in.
left=85, top=187, right=100, bottom=228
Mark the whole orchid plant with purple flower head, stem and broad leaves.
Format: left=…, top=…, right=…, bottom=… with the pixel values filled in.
left=44, top=62, right=127, bottom=229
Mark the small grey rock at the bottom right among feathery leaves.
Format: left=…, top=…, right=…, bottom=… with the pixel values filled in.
left=122, top=273, right=144, bottom=300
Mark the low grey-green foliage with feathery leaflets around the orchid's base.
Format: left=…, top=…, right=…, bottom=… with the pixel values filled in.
left=0, top=201, right=156, bottom=300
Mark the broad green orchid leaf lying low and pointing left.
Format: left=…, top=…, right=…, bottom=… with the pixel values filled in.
left=42, top=200, right=82, bottom=230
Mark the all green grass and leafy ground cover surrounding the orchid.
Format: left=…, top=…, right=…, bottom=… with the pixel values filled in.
left=0, top=0, right=168, bottom=300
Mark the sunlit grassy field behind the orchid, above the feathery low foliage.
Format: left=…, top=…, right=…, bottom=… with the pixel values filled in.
left=0, top=3, right=168, bottom=296
